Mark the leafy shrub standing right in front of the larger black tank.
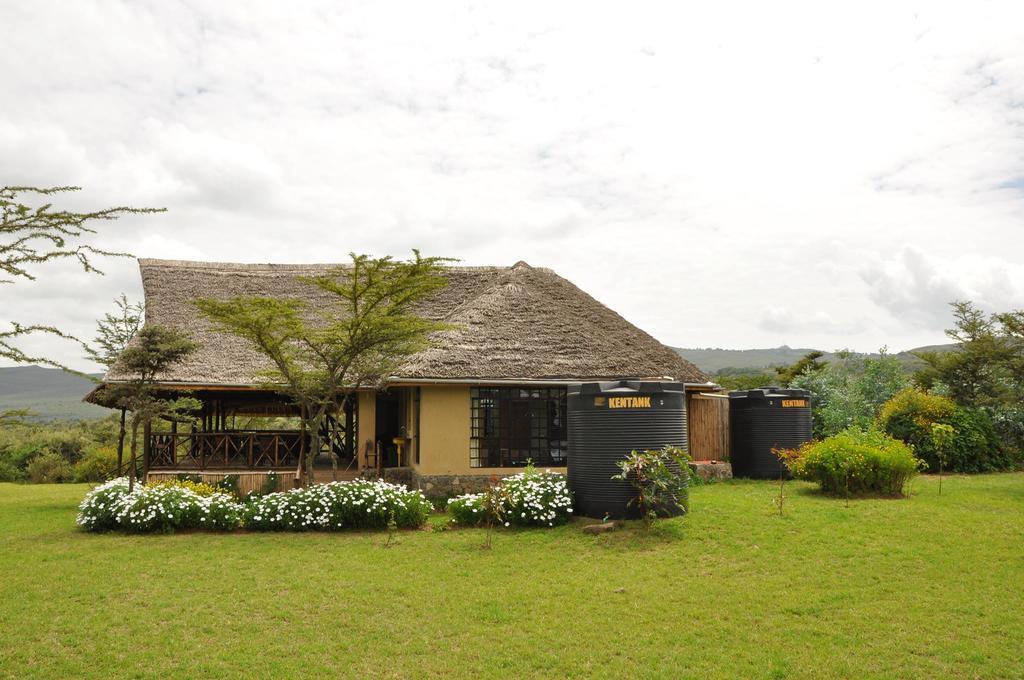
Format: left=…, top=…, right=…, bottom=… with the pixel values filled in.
left=611, top=447, right=690, bottom=529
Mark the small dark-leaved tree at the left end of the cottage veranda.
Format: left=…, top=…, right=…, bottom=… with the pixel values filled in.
left=111, top=326, right=202, bottom=491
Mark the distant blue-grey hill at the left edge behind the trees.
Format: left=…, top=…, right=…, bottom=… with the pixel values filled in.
left=0, top=366, right=111, bottom=420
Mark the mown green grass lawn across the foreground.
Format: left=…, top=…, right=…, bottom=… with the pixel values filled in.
left=0, top=473, right=1024, bottom=678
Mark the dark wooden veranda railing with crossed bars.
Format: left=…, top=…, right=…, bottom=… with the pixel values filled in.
left=150, top=430, right=303, bottom=470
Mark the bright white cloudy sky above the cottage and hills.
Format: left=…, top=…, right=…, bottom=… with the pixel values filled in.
left=0, top=0, right=1024, bottom=368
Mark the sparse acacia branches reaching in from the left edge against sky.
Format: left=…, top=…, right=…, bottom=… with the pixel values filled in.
left=0, top=186, right=164, bottom=369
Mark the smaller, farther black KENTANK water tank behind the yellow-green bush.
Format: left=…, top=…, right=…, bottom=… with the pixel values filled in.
left=729, top=387, right=812, bottom=479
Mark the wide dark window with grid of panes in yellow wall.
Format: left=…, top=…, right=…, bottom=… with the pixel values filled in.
left=469, top=387, right=568, bottom=467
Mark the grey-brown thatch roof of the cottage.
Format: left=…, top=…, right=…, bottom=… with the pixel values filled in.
left=106, top=259, right=708, bottom=385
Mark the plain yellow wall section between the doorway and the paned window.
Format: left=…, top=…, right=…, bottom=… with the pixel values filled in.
left=413, top=385, right=569, bottom=475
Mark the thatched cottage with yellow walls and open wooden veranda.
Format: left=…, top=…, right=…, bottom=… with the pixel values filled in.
left=93, top=259, right=708, bottom=493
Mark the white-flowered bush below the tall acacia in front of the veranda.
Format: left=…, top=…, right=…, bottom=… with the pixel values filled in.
left=245, top=480, right=433, bottom=532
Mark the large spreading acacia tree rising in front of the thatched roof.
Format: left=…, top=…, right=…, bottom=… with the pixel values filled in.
left=196, top=250, right=453, bottom=483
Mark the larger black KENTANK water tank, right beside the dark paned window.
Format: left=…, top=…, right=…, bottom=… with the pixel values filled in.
left=568, top=380, right=686, bottom=519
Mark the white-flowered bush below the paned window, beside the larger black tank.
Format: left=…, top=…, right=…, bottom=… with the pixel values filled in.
left=447, top=465, right=572, bottom=526
